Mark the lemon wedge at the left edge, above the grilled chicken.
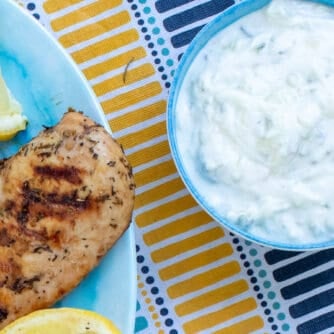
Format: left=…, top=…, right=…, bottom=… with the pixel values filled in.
left=0, top=71, right=27, bottom=141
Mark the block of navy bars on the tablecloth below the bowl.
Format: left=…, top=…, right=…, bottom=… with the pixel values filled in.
left=264, top=249, right=334, bottom=334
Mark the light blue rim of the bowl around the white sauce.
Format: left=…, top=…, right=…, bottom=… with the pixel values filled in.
left=167, top=0, right=334, bottom=251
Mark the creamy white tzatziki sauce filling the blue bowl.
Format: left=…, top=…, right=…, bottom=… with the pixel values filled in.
left=175, top=0, right=334, bottom=244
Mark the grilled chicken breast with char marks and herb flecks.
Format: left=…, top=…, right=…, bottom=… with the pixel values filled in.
left=0, top=110, right=135, bottom=328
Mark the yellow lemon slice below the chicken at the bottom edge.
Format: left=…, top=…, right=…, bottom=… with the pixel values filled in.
left=0, top=307, right=121, bottom=334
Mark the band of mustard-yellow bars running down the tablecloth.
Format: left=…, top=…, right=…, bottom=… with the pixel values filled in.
left=39, top=0, right=263, bottom=334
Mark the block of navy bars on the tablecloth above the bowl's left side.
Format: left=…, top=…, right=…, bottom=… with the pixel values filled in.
left=155, top=0, right=235, bottom=48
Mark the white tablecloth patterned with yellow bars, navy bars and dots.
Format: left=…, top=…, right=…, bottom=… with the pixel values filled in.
left=17, top=0, right=334, bottom=334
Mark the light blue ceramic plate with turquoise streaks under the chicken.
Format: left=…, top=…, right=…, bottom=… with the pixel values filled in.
left=0, top=0, right=136, bottom=334
